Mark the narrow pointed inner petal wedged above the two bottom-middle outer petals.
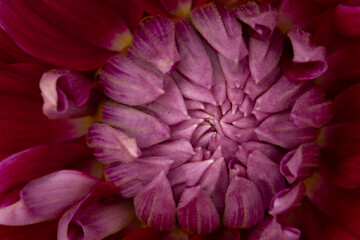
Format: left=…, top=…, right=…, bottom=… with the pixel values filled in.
left=199, top=158, right=229, bottom=213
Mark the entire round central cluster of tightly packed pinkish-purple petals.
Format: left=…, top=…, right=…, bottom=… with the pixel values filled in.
left=88, top=3, right=330, bottom=234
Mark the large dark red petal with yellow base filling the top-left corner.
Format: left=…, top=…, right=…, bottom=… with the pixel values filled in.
left=0, top=0, right=131, bottom=70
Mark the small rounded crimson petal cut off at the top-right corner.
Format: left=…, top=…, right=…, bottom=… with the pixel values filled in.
left=334, top=4, right=360, bottom=37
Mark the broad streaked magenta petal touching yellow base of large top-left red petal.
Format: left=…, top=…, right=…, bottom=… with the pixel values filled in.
left=129, top=16, right=180, bottom=74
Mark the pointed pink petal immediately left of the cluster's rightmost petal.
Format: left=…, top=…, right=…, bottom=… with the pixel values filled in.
left=255, top=76, right=308, bottom=113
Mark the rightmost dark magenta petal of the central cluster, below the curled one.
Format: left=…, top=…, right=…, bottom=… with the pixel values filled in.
left=290, top=87, right=332, bottom=127
